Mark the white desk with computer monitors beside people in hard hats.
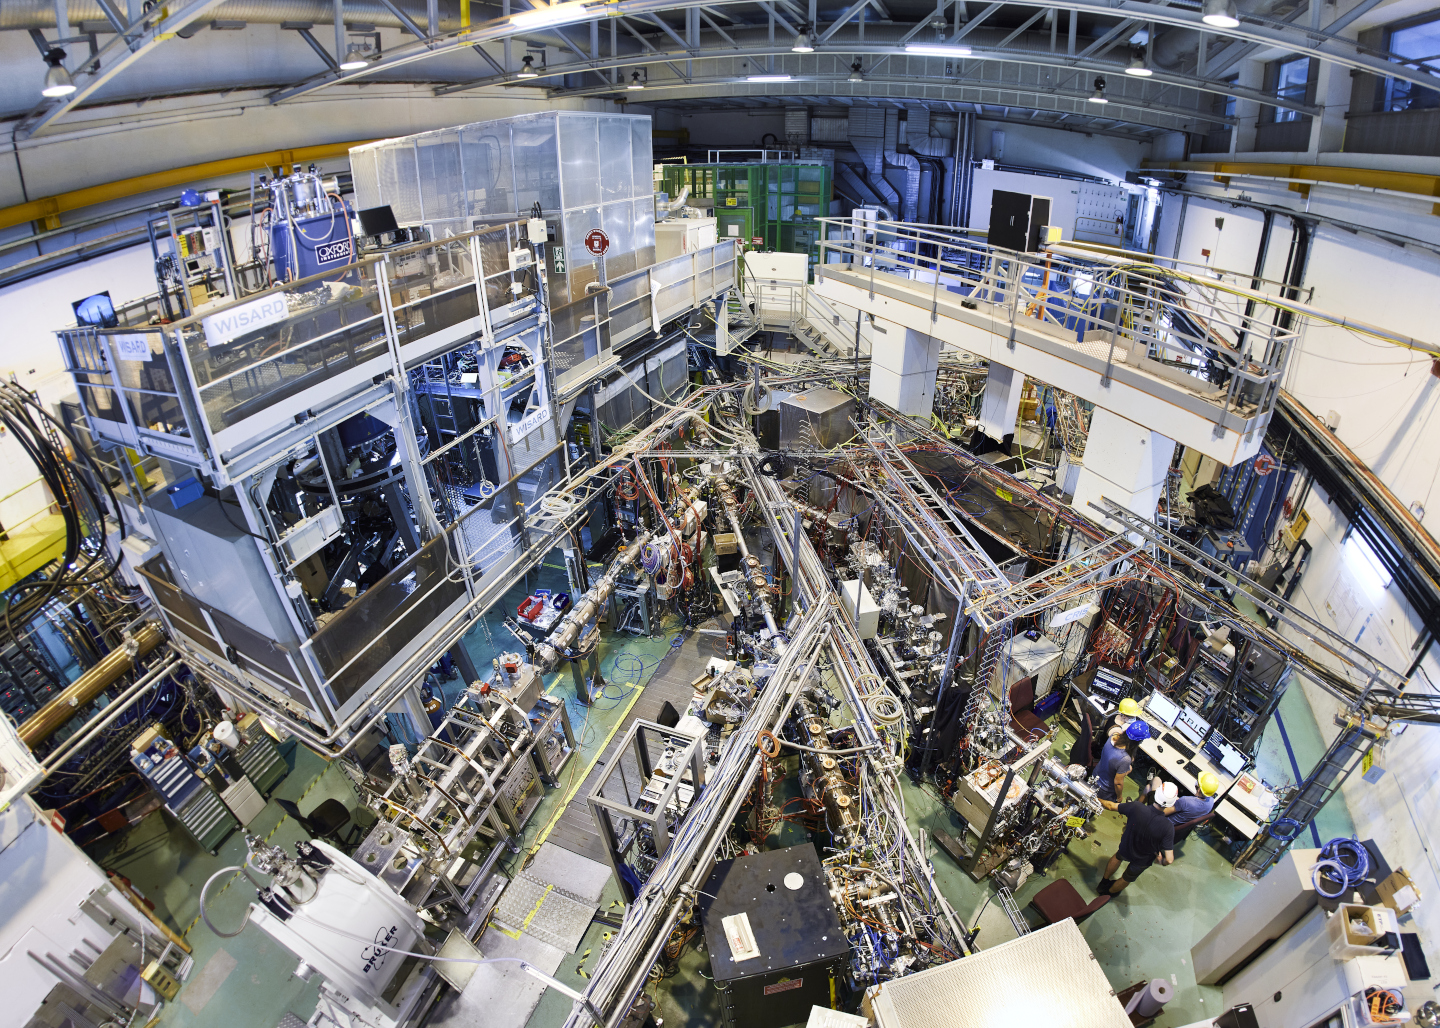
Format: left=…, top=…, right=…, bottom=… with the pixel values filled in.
left=1140, top=693, right=1276, bottom=839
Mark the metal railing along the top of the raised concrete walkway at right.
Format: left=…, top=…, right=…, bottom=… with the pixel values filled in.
left=816, top=217, right=1303, bottom=422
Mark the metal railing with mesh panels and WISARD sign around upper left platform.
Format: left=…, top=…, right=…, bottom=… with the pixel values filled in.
left=56, top=222, right=530, bottom=478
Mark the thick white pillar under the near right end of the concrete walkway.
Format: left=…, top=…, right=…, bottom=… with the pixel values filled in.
left=1071, top=407, right=1175, bottom=521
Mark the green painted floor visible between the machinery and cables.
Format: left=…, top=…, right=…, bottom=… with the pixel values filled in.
left=91, top=554, right=1354, bottom=1028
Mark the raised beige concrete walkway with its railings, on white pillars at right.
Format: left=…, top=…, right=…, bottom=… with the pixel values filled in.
left=812, top=219, right=1299, bottom=465
